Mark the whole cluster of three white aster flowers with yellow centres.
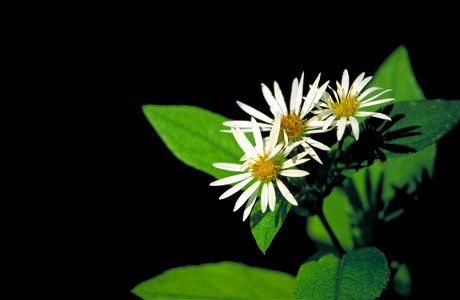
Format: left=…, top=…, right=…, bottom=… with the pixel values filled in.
left=211, top=70, right=394, bottom=221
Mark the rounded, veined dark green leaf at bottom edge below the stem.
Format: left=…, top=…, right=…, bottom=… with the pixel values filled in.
left=295, top=247, right=390, bottom=299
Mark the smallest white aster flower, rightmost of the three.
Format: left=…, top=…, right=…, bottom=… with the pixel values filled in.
left=312, top=69, right=394, bottom=140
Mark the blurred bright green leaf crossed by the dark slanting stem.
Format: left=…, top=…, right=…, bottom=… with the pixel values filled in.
left=307, top=189, right=354, bottom=251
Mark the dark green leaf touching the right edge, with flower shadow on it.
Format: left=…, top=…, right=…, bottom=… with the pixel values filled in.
left=386, top=100, right=460, bottom=157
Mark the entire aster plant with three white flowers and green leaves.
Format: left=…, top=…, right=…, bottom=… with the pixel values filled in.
left=133, top=47, right=460, bottom=299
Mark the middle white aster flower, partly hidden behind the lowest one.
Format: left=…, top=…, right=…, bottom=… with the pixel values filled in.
left=224, top=73, right=330, bottom=163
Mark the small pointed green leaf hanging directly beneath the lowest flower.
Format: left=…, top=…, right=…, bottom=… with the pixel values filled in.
left=251, top=197, right=291, bottom=254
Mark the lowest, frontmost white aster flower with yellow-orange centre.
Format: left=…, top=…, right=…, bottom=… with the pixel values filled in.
left=210, top=115, right=309, bottom=221
